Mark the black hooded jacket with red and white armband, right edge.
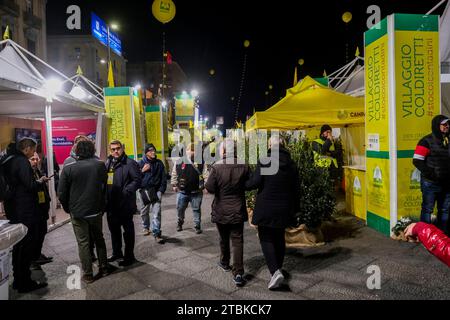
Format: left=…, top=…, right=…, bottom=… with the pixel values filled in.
left=413, top=115, right=450, bottom=184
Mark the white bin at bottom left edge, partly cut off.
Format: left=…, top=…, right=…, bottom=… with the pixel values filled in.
left=0, top=221, right=28, bottom=300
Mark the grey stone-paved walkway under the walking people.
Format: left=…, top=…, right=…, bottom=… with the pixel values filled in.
left=10, top=189, right=450, bottom=300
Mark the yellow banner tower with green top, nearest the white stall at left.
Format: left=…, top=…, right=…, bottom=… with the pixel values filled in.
left=104, top=87, right=142, bottom=160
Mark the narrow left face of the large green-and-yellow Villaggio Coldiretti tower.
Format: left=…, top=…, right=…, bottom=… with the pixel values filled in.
left=364, top=19, right=390, bottom=233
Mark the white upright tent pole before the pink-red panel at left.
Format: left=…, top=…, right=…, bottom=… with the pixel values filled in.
left=45, top=99, right=58, bottom=225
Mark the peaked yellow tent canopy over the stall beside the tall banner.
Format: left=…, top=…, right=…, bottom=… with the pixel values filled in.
left=246, top=77, right=365, bottom=131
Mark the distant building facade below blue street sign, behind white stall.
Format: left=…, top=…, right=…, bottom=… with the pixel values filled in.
left=48, top=35, right=127, bottom=87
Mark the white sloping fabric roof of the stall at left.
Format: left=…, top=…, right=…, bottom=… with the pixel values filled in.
left=0, top=40, right=104, bottom=118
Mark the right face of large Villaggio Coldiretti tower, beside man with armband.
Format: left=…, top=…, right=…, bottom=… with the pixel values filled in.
left=394, top=14, right=441, bottom=219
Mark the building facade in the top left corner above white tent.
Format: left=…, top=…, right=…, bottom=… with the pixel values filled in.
left=0, top=0, right=47, bottom=60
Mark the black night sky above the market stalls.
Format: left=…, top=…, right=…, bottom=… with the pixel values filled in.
left=47, top=0, right=444, bottom=127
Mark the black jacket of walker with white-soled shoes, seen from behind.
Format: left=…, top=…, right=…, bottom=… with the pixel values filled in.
left=246, top=147, right=300, bottom=229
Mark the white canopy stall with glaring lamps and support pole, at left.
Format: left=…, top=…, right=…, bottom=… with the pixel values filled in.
left=0, top=39, right=105, bottom=222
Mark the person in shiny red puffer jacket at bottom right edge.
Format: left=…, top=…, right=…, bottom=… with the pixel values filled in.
left=405, top=222, right=450, bottom=267
